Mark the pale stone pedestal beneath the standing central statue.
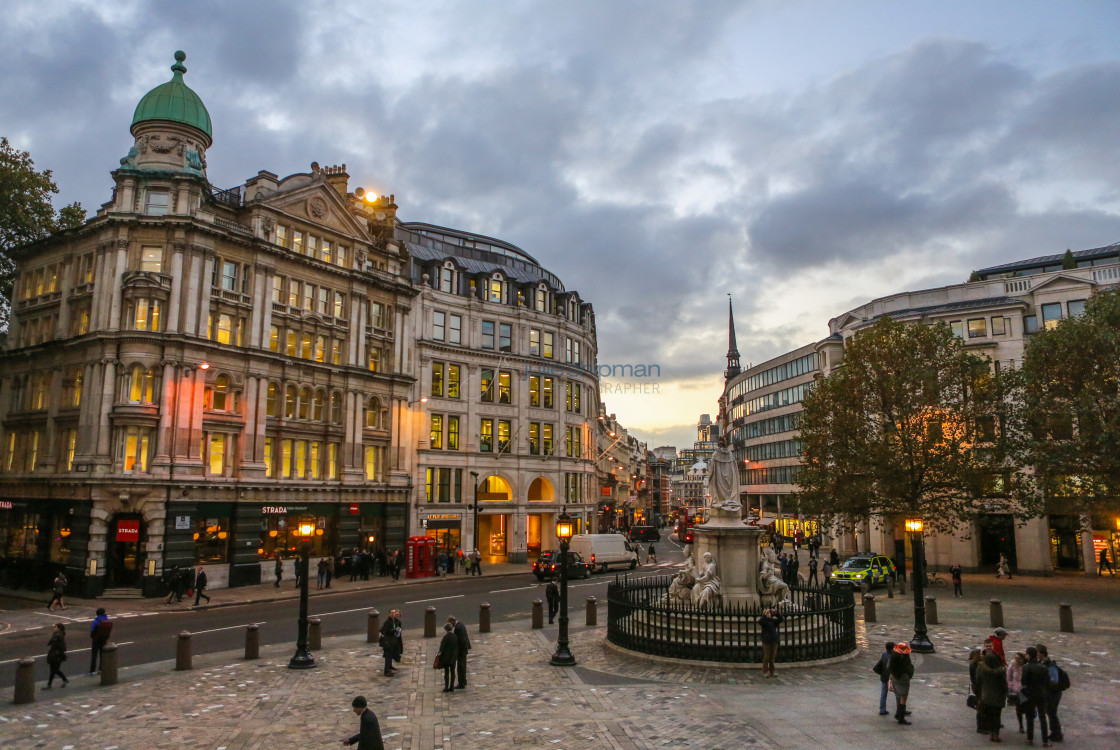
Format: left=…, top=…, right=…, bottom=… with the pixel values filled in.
left=693, top=508, right=765, bottom=608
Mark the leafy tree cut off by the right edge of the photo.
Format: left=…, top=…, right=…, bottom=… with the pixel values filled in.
left=1015, top=290, right=1120, bottom=514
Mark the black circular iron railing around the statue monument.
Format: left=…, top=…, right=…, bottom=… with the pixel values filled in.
left=607, top=576, right=857, bottom=664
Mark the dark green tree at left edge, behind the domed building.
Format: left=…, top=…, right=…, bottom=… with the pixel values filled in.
left=0, top=138, right=85, bottom=328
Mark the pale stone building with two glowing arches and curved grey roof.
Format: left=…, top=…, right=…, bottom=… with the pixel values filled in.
left=395, top=223, right=599, bottom=562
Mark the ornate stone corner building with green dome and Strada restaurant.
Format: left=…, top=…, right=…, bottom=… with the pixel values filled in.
left=0, top=53, right=418, bottom=596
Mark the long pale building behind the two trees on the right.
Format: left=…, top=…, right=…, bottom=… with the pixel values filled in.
left=724, top=244, right=1120, bottom=574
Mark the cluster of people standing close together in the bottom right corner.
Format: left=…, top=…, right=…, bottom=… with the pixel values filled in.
left=969, top=628, right=1070, bottom=747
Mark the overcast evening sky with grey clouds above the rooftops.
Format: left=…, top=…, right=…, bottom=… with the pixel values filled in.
left=0, top=0, right=1120, bottom=448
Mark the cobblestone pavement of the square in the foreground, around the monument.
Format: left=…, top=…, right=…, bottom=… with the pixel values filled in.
left=0, top=579, right=1120, bottom=750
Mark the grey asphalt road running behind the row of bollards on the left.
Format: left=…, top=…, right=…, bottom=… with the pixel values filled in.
left=0, top=536, right=682, bottom=687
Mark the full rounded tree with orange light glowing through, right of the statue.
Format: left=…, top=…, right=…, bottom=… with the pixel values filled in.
left=797, top=318, right=1011, bottom=533
